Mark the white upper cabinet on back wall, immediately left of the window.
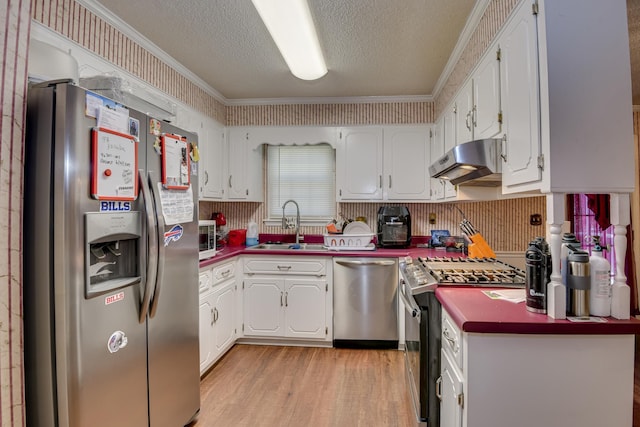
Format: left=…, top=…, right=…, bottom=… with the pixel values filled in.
left=225, top=127, right=263, bottom=202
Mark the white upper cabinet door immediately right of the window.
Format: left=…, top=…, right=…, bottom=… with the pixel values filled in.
left=336, top=127, right=383, bottom=200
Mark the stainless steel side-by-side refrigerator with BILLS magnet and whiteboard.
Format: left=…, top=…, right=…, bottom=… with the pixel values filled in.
left=23, top=82, right=200, bottom=427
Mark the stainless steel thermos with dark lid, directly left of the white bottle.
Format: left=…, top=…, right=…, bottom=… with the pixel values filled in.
left=566, top=249, right=591, bottom=317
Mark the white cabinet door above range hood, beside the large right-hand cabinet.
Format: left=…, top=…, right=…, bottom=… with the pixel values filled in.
left=472, top=50, right=502, bottom=139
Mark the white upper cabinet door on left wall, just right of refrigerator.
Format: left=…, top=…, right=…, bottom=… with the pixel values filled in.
left=199, top=120, right=225, bottom=200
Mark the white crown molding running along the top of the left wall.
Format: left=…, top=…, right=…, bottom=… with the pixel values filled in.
left=76, top=0, right=227, bottom=105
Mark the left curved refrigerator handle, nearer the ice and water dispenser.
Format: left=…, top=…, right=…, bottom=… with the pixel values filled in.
left=138, top=170, right=158, bottom=323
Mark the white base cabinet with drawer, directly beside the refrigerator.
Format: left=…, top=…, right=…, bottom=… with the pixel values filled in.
left=199, top=261, right=237, bottom=374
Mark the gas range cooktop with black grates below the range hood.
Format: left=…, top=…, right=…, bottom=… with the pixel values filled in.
left=400, top=257, right=525, bottom=295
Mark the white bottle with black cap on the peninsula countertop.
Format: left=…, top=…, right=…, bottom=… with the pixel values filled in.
left=589, top=236, right=611, bottom=317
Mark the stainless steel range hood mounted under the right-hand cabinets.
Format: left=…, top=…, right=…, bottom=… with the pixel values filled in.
left=429, top=138, right=502, bottom=187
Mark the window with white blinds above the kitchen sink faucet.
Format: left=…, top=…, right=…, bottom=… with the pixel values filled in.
left=267, top=144, right=336, bottom=224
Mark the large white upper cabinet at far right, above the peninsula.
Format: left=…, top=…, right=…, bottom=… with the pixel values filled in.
left=497, top=0, right=635, bottom=193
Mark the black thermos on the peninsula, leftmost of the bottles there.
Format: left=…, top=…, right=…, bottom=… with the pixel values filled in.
left=525, top=237, right=551, bottom=313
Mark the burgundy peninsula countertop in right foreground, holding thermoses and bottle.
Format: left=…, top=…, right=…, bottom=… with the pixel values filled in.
left=436, top=287, right=640, bottom=335
